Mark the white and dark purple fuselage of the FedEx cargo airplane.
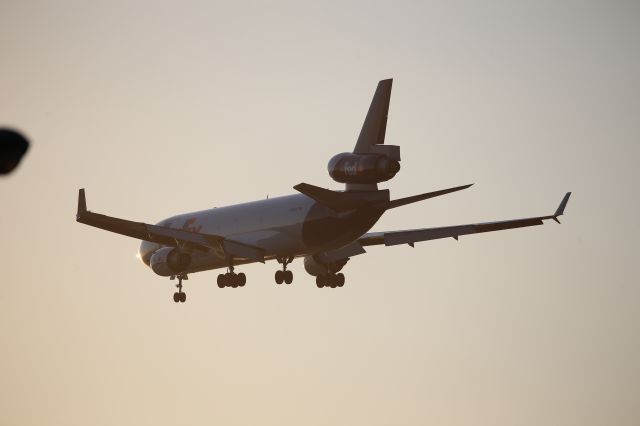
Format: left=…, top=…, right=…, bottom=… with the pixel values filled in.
left=139, top=194, right=384, bottom=276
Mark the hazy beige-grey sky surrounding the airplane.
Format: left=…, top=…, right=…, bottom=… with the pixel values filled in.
left=0, top=0, right=640, bottom=426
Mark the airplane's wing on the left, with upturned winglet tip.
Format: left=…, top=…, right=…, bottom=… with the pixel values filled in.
left=76, top=189, right=264, bottom=263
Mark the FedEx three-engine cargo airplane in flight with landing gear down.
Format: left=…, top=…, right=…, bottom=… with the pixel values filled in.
left=76, top=79, right=571, bottom=303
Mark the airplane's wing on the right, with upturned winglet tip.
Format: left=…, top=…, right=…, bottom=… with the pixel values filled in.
left=358, top=192, right=571, bottom=247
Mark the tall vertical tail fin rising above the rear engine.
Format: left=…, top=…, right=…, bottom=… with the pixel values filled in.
left=353, top=78, right=393, bottom=154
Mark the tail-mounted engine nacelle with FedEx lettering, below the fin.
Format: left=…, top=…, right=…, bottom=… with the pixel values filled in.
left=327, top=152, right=400, bottom=184
